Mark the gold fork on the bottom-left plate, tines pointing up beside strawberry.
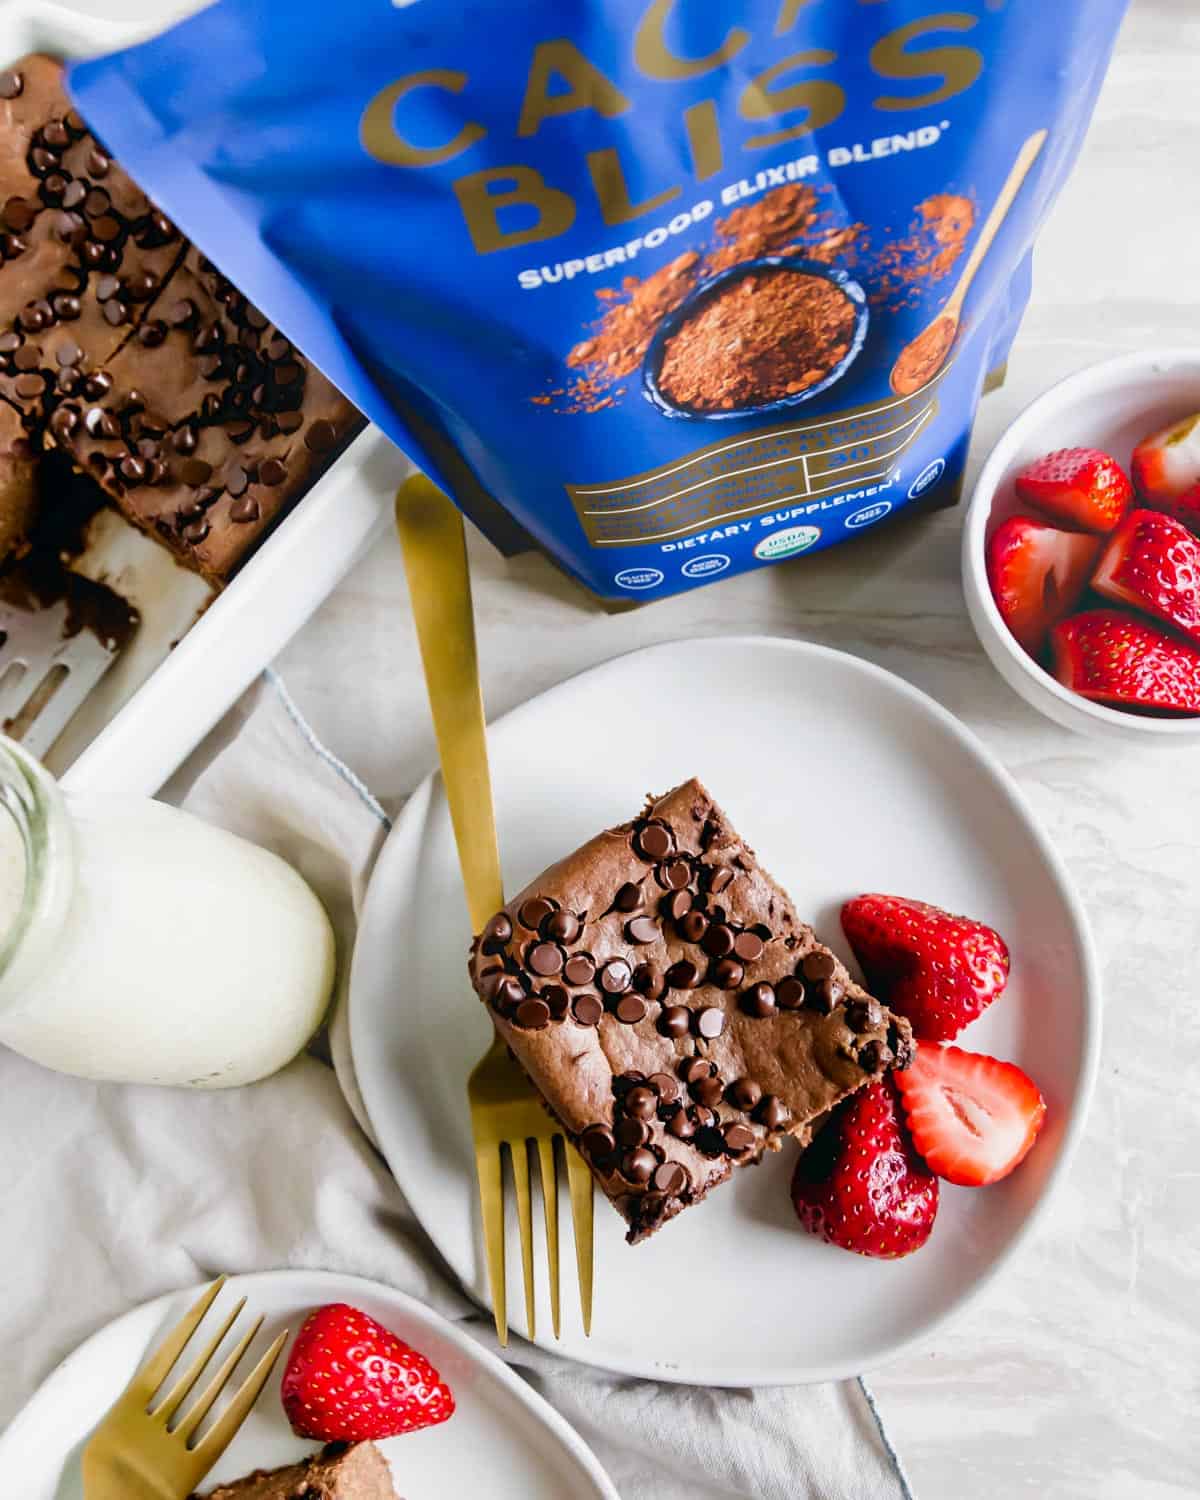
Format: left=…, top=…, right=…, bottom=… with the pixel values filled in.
left=83, top=1277, right=288, bottom=1500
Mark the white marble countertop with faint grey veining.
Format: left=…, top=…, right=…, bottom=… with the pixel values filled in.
left=211, top=0, right=1200, bottom=1500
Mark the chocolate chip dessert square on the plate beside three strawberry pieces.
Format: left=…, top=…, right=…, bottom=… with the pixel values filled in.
left=470, top=780, right=914, bottom=1244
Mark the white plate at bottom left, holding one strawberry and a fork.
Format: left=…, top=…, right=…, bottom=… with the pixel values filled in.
left=0, top=1271, right=618, bottom=1500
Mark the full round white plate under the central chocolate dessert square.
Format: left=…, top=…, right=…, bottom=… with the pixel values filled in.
left=350, top=638, right=1100, bottom=1386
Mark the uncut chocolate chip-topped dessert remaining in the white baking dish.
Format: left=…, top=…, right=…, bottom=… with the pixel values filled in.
left=0, top=56, right=363, bottom=584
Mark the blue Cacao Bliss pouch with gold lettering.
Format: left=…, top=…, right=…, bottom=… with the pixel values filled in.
left=69, top=0, right=1125, bottom=600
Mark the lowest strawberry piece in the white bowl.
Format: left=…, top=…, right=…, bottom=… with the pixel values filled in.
left=1050, top=609, right=1200, bottom=714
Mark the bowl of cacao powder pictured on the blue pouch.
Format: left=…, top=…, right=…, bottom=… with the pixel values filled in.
left=644, top=255, right=869, bottom=422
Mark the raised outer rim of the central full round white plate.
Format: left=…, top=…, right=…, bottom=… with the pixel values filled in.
left=348, top=635, right=1103, bottom=1389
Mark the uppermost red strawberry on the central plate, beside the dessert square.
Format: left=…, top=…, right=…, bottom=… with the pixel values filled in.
left=842, top=896, right=1010, bottom=1041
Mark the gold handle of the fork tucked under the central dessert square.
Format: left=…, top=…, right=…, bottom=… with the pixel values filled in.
left=396, top=474, right=504, bottom=933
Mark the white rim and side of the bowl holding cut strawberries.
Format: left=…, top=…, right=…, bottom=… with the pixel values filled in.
left=963, top=347, right=1200, bottom=740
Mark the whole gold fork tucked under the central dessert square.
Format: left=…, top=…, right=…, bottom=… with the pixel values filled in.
left=396, top=476, right=593, bottom=1344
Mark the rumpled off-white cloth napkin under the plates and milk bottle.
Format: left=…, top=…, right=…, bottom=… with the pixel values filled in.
left=0, top=674, right=912, bottom=1500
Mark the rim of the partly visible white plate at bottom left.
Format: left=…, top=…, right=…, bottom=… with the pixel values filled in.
left=0, top=1266, right=621, bottom=1500
